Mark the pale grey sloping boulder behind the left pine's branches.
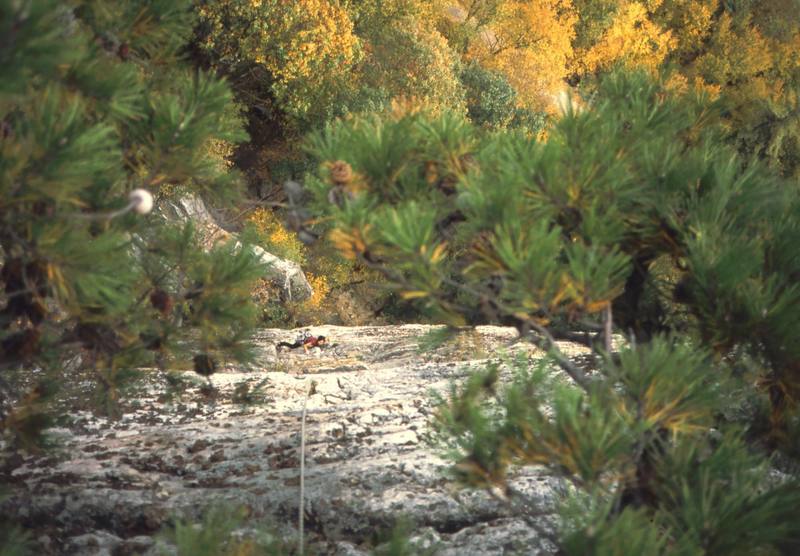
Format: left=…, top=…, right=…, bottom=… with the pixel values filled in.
left=159, top=195, right=314, bottom=301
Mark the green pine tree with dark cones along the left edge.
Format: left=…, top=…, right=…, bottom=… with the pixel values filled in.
left=0, top=0, right=261, bottom=447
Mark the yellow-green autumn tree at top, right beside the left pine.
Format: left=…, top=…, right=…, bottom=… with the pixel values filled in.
left=195, top=0, right=463, bottom=138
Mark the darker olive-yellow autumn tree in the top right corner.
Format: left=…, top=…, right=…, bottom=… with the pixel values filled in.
left=669, top=6, right=800, bottom=173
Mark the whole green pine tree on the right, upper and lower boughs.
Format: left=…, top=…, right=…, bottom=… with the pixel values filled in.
left=307, top=73, right=800, bottom=555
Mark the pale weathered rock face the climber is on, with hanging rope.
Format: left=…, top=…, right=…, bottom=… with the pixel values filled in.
left=0, top=325, right=592, bottom=556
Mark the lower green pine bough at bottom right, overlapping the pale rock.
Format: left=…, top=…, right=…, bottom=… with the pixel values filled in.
left=435, top=339, right=800, bottom=555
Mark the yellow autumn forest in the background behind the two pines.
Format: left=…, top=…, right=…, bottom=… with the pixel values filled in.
left=192, top=0, right=799, bottom=325
